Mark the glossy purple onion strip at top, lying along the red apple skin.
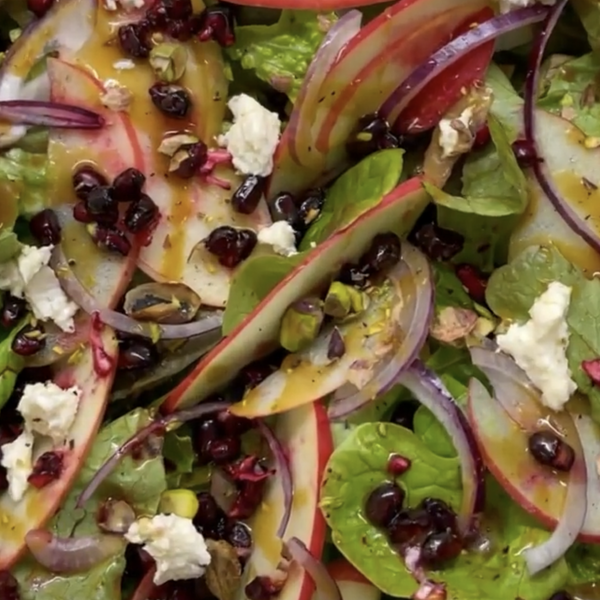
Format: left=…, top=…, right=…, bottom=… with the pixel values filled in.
left=380, top=4, right=550, bottom=123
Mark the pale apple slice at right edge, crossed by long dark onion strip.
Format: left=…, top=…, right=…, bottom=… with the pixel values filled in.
left=510, top=109, right=600, bottom=275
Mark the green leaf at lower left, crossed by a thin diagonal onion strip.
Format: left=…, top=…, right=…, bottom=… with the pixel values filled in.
left=51, top=408, right=167, bottom=536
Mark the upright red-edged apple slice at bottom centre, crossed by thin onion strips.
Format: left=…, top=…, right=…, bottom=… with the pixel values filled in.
left=241, top=402, right=333, bottom=600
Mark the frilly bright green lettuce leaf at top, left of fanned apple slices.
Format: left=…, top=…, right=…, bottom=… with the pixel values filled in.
left=227, top=10, right=336, bottom=101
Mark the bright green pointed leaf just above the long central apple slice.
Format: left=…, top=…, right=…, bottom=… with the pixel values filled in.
left=300, top=149, right=404, bottom=250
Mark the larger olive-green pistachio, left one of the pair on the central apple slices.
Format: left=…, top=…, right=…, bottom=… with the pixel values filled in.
left=279, top=298, right=325, bottom=352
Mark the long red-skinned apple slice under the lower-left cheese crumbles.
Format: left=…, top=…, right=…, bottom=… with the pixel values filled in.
left=0, top=327, right=118, bottom=571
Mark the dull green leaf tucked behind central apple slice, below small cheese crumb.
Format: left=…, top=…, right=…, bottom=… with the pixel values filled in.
left=222, top=252, right=306, bottom=335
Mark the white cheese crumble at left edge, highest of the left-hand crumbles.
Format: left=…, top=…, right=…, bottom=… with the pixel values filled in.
left=0, top=246, right=79, bottom=332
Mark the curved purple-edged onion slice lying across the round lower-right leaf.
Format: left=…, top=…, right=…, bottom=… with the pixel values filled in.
left=397, top=360, right=485, bottom=533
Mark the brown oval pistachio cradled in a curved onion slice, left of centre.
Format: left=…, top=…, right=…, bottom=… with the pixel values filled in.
left=123, top=283, right=202, bottom=324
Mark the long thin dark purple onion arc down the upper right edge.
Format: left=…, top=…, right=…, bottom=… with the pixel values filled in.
left=523, top=0, right=600, bottom=247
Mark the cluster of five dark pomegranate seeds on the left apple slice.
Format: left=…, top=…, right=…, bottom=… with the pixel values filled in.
left=73, top=166, right=160, bottom=256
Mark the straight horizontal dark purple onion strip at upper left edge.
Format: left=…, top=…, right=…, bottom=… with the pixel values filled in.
left=0, top=100, right=105, bottom=129
